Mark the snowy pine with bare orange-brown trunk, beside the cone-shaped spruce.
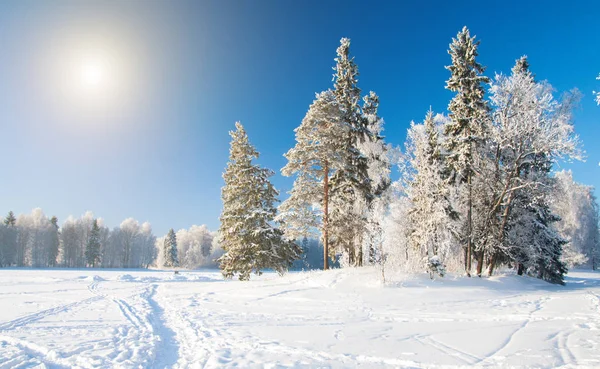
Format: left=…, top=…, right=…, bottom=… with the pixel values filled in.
left=277, top=90, right=348, bottom=269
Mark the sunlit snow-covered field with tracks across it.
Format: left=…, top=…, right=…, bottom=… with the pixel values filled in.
left=0, top=268, right=600, bottom=368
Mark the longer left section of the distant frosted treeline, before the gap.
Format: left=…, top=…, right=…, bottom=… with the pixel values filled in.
left=0, top=208, right=156, bottom=268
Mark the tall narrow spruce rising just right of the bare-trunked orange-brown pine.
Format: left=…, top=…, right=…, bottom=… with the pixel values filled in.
left=330, top=38, right=373, bottom=265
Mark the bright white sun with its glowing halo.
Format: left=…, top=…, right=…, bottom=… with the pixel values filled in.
left=42, top=38, right=139, bottom=123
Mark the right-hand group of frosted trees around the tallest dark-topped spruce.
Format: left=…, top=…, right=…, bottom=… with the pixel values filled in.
left=380, top=27, right=600, bottom=284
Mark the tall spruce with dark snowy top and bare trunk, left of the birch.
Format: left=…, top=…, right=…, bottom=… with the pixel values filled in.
left=445, top=26, right=489, bottom=276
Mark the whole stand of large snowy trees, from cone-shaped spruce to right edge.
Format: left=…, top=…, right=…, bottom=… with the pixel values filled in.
left=219, top=27, right=600, bottom=284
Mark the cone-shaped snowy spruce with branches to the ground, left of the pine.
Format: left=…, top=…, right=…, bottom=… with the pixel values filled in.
left=219, top=122, right=301, bottom=280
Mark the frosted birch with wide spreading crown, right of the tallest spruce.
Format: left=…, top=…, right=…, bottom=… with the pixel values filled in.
left=485, top=58, right=581, bottom=275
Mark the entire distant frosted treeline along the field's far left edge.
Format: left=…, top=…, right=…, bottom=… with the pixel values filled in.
left=0, top=209, right=222, bottom=269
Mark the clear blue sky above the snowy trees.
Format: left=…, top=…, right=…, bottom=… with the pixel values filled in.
left=0, top=0, right=600, bottom=235
